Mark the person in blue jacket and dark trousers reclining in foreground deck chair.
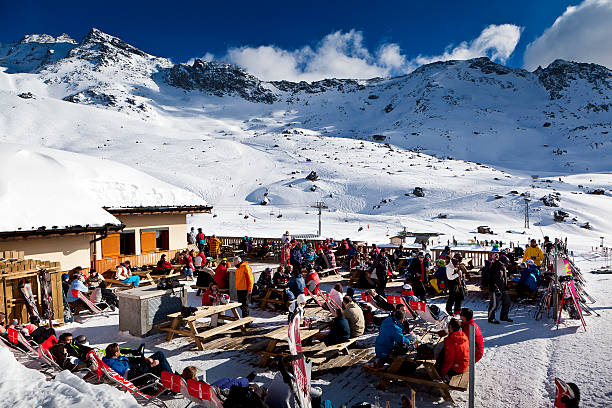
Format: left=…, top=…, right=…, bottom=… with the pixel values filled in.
left=102, top=343, right=174, bottom=380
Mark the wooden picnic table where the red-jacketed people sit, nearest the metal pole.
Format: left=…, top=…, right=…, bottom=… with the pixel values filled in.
left=363, top=332, right=469, bottom=403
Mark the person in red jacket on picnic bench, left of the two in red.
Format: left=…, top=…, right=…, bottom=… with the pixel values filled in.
left=435, top=319, right=470, bottom=382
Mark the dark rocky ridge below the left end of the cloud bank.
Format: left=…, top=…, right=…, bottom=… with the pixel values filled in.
left=166, top=59, right=276, bottom=103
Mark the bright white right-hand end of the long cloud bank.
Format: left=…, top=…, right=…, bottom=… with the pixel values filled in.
left=414, top=24, right=521, bottom=65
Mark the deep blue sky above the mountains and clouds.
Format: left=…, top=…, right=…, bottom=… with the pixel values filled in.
left=0, top=0, right=607, bottom=80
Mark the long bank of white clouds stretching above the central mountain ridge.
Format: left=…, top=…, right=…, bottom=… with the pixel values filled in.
left=212, top=24, right=521, bottom=82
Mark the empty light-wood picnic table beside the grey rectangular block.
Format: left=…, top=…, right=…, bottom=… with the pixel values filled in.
left=160, top=302, right=255, bottom=350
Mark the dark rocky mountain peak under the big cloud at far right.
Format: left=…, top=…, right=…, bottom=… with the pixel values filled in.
left=534, top=59, right=612, bottom=99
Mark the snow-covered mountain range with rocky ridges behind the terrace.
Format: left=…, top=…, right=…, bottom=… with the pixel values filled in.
left=0, top=29, right=612, bottom=244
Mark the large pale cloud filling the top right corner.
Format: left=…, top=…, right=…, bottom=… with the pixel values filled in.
left=524, top=0, right=612, bottom=70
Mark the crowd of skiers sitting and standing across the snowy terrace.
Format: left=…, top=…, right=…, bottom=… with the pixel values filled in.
left=0, top=228, right=572, bottom=408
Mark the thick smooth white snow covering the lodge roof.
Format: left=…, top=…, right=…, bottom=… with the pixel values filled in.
left=0, top=143, right=206, bottom=231
